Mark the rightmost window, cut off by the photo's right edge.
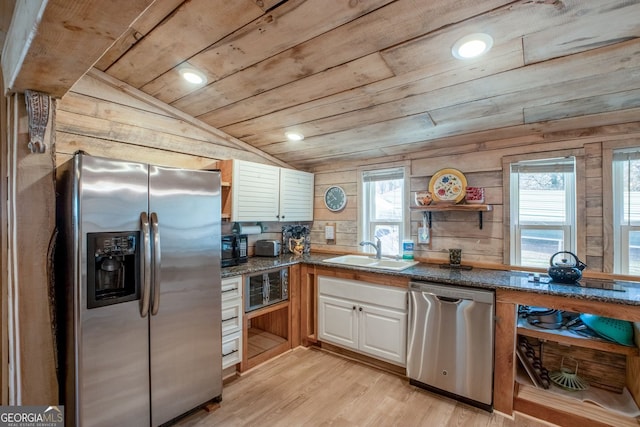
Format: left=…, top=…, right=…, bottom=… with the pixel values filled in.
left=612, top=147, right=640, bottom=276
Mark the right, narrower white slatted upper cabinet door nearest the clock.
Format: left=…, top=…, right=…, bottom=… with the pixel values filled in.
left=280, top=168, right=313, bottom=221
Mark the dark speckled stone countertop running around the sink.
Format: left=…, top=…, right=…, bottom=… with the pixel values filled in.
left=222, top=254, right=640, bottom=306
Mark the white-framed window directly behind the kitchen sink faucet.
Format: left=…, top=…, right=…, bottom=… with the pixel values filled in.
left=361, top=167, right=408, bottom=256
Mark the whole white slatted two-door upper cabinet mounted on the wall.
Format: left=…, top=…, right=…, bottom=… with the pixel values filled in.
left=222, top=160, right=314, bottom=222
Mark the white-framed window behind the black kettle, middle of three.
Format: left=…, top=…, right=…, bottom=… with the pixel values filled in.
left=509, top=157, right=576, bottom=267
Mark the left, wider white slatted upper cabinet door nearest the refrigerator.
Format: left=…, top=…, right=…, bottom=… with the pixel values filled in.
left=231, top=160, right=280, bottom=222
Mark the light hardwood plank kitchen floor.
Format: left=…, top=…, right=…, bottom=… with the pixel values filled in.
left=178, top=347, right=549, bottom=427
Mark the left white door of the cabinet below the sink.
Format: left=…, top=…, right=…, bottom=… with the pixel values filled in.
left=318, top=295, right=358, bottom=350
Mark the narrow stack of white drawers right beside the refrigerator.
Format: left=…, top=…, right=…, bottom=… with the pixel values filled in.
left=222, top=276, right=242, bottom=369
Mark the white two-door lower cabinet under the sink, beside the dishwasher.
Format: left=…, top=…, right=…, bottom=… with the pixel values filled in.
left=318, top=276, right=408, bottom=366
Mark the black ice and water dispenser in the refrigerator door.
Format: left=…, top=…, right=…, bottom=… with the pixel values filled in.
left=87, top=231, right=140, bottom=308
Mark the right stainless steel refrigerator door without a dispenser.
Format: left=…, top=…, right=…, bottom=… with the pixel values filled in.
left=149, top=166, right=222, bottom=426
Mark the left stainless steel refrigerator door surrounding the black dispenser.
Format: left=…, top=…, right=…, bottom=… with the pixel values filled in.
left=74, top=154, right=150, bottom=426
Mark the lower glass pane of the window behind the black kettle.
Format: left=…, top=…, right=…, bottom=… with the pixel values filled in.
left=520, top=229, right=564, bottom=267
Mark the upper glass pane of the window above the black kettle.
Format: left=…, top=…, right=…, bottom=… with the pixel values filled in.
left=518, top=173, right=567, bottom=224
